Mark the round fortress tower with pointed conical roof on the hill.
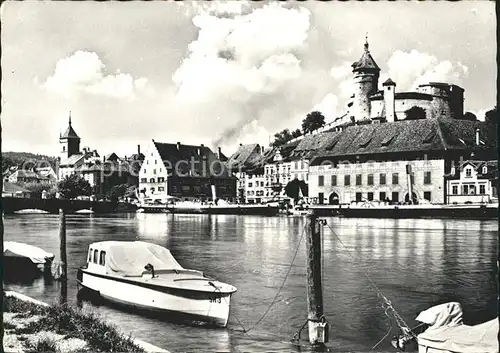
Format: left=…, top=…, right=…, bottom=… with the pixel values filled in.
left=350, top=38, right=380, bottom=121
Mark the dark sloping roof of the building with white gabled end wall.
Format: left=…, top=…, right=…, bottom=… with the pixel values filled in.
left=154, top=142, right=231, bottom=178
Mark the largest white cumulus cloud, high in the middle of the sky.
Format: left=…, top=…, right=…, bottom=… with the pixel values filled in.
left=172, top=3, right=312, bottom=144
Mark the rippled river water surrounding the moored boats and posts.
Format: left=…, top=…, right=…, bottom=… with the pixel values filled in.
left=5, top=214, right=498, bottom=352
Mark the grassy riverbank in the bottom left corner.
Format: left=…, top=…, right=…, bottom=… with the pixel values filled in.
left=3, top=295, right=144, bottom=353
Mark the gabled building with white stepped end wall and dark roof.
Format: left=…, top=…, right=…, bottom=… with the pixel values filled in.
left=139, top=140, right=237, bottom=200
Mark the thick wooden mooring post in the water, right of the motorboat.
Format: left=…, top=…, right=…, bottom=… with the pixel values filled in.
left=306, top=211, right=329, bottom=346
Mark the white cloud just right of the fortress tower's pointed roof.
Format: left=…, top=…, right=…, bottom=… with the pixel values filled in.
left=382, top=49, right=469, bottom=91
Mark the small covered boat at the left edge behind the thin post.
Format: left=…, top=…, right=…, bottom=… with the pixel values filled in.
left=3, top=241, right=54, bottom=277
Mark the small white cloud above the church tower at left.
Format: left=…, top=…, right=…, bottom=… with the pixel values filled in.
left=41, top=50, right=148, bottom=99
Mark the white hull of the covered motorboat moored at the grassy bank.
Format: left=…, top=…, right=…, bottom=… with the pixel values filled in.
left=78, top=269, right=231, bottom=327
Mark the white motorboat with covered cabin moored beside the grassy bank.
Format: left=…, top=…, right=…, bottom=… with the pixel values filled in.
left=77, top=241, right=236, bottom=327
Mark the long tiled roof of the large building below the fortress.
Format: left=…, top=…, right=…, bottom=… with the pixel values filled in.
left=314, top=118, right=497, bottom=163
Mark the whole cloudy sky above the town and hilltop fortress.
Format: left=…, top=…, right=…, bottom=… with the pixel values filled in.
left=1, top=1, right=496, bottom=155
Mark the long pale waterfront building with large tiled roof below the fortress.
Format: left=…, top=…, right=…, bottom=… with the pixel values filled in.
left=309, top=118, right=497, bottom=204
